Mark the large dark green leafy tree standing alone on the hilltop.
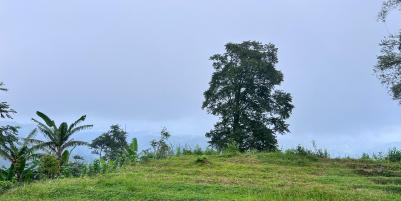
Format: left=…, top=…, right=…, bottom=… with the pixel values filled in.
left=202, top=41, right=294, bottom=151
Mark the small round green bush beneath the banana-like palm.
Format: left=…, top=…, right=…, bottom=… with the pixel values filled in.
left=39, top=155, right=61, bottom=179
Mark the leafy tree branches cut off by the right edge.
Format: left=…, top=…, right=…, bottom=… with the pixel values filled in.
left=374, top=0, right=401, bottom=103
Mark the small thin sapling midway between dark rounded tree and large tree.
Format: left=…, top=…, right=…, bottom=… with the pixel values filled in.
left=150, top=128, right=173, bottom=159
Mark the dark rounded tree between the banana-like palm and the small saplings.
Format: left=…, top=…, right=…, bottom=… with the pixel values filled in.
left=90, top=125, right=128, bottom=160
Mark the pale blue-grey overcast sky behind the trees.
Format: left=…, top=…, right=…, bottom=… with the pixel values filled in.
left=0, top=0, right=401, bottom=156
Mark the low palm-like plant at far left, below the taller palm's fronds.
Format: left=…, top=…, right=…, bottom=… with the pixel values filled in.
left=0, top=129, right=38, bottom=182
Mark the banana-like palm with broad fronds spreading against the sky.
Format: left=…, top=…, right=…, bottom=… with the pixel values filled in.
left=31, top=111, right=93, bottom=166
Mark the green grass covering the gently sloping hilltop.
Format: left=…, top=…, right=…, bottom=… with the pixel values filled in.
left=0, top=153, right=401, bottom=201
